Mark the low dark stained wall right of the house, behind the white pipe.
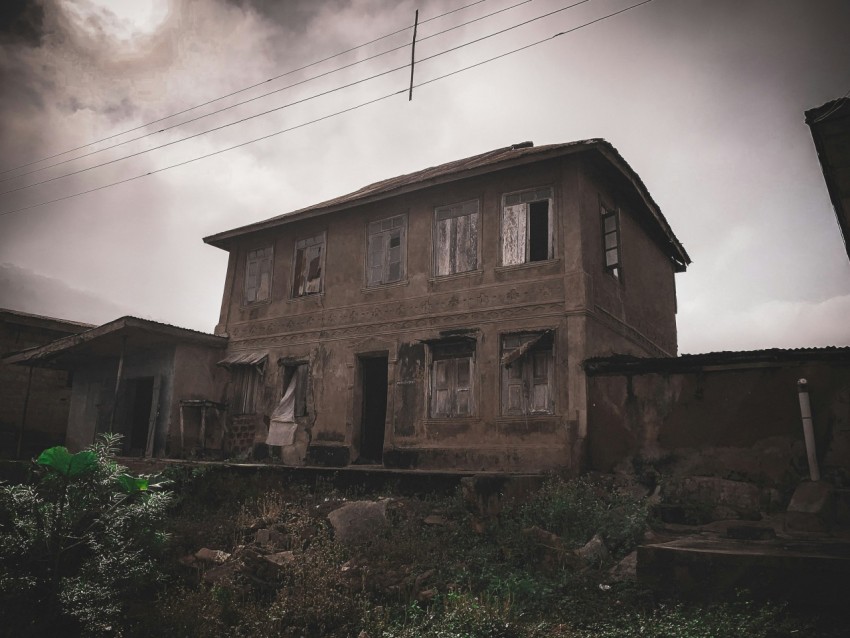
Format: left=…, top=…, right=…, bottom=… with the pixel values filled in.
left=588, top=355, right=850, bottom=480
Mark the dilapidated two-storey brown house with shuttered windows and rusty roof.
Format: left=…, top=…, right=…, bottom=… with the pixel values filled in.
left=204, top=139, right=690, bottom=471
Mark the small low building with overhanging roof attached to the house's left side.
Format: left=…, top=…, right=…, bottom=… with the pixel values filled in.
left=4, top=317, right=227, bottom=456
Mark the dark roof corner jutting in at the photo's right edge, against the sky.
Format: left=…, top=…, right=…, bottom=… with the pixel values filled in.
left=806, top=97, right=850, bottom=257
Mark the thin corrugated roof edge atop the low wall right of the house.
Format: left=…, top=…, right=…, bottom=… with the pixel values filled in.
left=584, top=346, right=850, bottom=375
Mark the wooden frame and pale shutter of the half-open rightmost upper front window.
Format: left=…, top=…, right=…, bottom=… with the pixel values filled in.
left=499, top=186, right=555, bottom=266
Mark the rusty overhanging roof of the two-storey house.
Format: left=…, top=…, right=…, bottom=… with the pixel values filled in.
left=204, top=139, right=691, bottom=272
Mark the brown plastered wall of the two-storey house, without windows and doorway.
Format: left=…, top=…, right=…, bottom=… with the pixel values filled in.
left=216, top=157, right=675, bottom=471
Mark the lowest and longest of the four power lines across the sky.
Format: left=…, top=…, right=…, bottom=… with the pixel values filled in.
left=0, top=0, right=653, bottom=216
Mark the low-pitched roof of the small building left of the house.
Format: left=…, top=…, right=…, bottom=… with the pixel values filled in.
left=3, top=317, right=227, bottom=368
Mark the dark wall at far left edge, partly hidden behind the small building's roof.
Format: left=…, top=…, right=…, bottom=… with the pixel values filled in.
left=0, top=313, right=90, bottom=458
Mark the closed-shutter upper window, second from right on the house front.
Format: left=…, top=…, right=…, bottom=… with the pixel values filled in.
left=434, top=200, right=478, bottom=277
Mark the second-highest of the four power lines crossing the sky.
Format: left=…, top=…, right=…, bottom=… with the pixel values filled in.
left=0, top=0, right=533, bottom=185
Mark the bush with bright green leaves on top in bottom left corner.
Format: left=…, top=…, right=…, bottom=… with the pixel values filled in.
left=0, top=435, right=170, bottom=636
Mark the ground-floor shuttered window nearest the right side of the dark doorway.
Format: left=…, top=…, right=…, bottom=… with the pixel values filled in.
left=431, top=341, right=475, bottom=418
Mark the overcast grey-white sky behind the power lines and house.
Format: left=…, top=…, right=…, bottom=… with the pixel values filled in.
left=0, top=0, right=850, bottom=353
